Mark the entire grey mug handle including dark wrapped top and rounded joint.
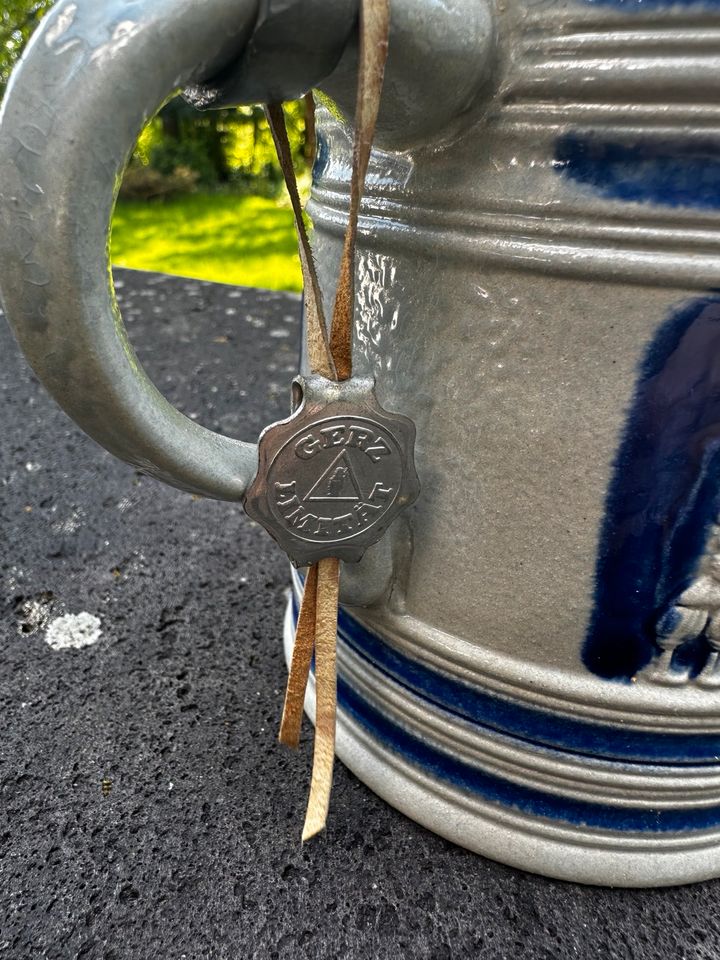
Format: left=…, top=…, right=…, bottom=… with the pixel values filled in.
left=0, top=0, right=494, bottom=500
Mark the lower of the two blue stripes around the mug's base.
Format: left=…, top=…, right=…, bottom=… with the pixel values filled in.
left=338, top=678, right=720, bottom=833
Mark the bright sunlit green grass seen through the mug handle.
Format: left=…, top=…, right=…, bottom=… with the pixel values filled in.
left=111, top=194, right=302, bottom=291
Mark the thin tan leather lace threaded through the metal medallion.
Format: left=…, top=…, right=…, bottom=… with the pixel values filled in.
left=265, top=0, right=390, bottom=841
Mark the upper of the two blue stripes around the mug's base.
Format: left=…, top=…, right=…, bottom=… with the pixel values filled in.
left=294, top=602, right=720, bottom=765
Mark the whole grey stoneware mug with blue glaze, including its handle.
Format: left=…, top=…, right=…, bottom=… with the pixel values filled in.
left=0, top=0, right=720, bottom=886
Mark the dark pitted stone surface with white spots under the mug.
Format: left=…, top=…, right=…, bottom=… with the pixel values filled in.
left=0, top=271, right=720, bottom=960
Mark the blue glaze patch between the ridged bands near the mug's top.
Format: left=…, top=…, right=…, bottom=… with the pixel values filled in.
left=555, top=133, right=720, bottom=210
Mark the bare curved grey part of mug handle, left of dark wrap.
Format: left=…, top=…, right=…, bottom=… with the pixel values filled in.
left=0, top=0, right=306, bottom=500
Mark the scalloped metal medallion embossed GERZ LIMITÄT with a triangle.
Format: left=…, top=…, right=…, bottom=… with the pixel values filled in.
left=244, top=377, right=420, bottom=566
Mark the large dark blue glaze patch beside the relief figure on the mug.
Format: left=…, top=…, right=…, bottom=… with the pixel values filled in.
left=583, top=296, right=720, bottom=679
